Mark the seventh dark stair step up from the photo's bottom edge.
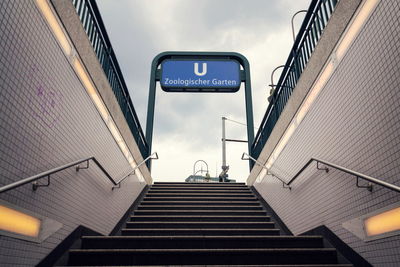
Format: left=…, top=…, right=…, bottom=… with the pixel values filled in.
left=140, top=200, right=261, bottom=206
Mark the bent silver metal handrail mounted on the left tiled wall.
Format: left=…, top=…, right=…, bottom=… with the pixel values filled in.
left=0, top=152, right=158, bottom=193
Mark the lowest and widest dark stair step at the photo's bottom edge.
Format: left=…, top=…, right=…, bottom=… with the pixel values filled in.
left=69, top=248, right=337, bottom=266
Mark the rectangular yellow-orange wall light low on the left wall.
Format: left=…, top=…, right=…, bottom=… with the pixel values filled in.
left=0, top=205, right=41, bottom=238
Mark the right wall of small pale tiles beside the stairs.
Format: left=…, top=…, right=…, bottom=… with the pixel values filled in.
left=255, top=0, right=400, bottom=266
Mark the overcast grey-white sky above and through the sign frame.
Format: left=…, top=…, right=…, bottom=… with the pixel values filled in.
left=97, top=0, right=310, bottom=182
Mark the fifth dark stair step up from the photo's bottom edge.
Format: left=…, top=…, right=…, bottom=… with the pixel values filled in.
left=131, top=215, right=271, bottom=222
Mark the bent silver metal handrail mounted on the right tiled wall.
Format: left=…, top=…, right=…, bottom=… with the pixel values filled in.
left=242, top=153, right=400, bottom=193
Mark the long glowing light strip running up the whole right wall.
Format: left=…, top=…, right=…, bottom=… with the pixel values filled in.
left=256, top=0, right=380, bottom=184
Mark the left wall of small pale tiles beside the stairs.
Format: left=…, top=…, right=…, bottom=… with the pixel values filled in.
left=0, top=0, right=144, bottom=266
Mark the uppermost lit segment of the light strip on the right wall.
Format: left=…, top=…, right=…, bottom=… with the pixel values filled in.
left=336, top=0, right=380, bottom=60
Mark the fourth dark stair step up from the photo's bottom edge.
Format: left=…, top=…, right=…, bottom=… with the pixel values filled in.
left=126, top=222, right=275, bottom=229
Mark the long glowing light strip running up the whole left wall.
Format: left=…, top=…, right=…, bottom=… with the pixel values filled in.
left=36, top=0, right=144, bottom=182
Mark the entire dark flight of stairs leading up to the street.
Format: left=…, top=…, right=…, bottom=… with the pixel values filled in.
left=63, top=183, right=351, bottom=267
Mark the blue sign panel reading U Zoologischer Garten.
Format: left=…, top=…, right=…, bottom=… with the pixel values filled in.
left=160, top=59, right=241, bottom=92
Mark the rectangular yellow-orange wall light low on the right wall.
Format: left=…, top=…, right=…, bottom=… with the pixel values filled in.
left=364, top=207, right=400, bottom=237
